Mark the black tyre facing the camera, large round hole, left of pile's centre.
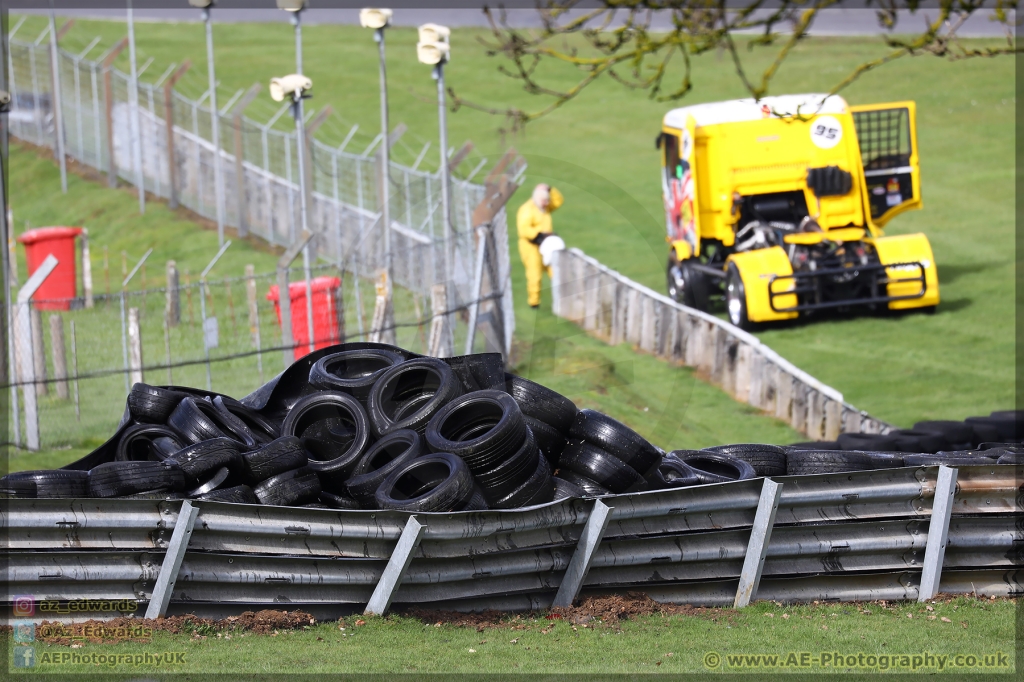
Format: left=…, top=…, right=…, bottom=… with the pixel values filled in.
left=281, top=391, right=370, bottom=487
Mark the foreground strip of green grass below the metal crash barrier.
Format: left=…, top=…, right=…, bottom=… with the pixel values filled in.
left=8, top=598, right=1015, bottom=679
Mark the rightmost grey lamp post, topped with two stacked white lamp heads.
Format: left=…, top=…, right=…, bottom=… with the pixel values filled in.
left=416, top=24, right=455, bottom=348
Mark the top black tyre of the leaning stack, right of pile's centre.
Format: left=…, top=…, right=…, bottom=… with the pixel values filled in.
left=426, top=391, right=526, bottom=475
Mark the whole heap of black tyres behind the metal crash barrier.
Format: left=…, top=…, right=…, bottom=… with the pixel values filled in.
left=0, top=343, right=1021, bottom=512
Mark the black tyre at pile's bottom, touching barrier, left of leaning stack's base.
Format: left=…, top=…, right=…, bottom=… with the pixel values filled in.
left=376, top=453, right=476, bottom=511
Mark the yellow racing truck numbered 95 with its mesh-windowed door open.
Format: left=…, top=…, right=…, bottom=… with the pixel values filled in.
left=656, top=94, right=939, bottom=329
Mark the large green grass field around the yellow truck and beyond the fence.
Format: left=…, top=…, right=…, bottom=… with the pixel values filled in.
left=12, top=11, right=1016, bottom=426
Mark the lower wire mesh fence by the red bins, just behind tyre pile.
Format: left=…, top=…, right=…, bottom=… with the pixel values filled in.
left=0, top=250, right=507, bottom=450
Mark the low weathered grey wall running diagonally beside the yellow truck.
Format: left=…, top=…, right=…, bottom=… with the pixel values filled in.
left=551, top=249, right=895, bottom=440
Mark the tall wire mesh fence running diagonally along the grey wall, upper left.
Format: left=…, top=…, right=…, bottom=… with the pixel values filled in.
left=8, top=33, right=524, bottom=366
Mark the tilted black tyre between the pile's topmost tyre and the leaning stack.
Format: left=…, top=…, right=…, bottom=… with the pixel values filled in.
left=367, top=357, right=462, bottom=437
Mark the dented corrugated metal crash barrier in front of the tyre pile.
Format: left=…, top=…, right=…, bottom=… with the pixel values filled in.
left=0, top=465, right=1024, bottom=617
